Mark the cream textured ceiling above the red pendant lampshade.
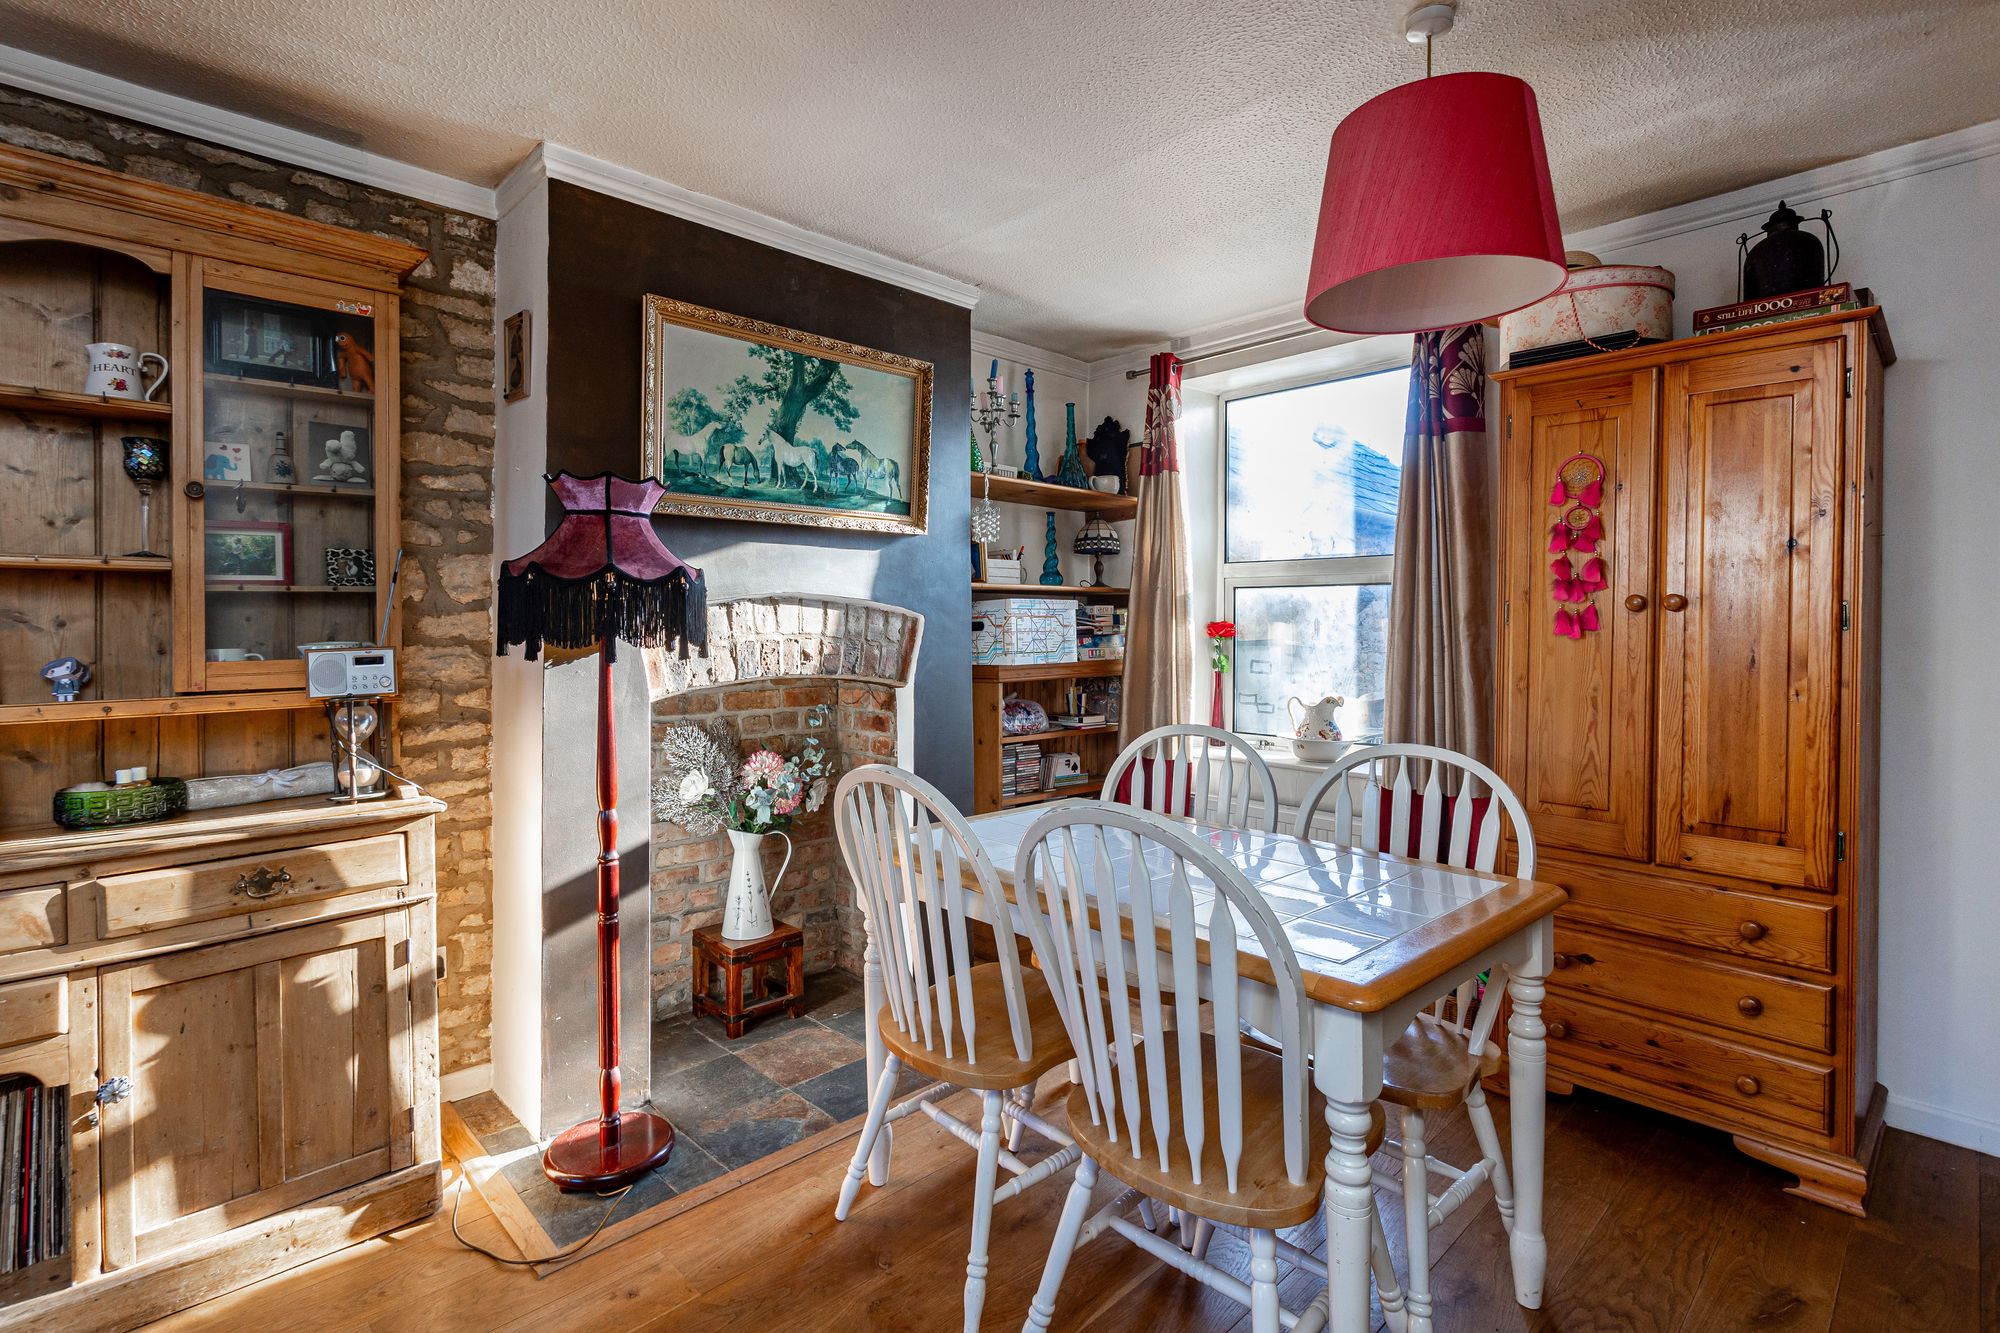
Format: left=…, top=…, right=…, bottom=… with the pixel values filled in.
left=0, top=0, right=2000, bottom=358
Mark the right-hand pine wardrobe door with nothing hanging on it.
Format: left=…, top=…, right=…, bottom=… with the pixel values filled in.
left=1658, top=340, right=1842, bottom=889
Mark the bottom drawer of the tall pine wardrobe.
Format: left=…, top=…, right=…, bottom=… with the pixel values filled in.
left=1542, top=993, right=1834, bottom=1135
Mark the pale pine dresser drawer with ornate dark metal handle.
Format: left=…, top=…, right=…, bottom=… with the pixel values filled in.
left=98, top=833, right=410, bottom=939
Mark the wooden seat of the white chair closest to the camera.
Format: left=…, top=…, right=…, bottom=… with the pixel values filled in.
left=1068, top=1035, right=1386, bottom=1231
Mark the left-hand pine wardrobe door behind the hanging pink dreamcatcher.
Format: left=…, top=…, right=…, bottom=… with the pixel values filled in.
left=1500, top=370, right=1658, bottom=859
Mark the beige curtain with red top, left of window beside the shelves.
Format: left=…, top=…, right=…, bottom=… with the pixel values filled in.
left=1118, top=352, right=1194, bottom=745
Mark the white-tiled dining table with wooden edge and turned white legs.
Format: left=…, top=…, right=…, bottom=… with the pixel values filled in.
left=862, top=801, right=1566, bottom=1333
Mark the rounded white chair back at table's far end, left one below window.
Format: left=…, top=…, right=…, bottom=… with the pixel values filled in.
left=1100, top=723, right=1278, bottom=833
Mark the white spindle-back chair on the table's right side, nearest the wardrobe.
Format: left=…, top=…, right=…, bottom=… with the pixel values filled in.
left=1294, top=745, right=1534, bottom=1333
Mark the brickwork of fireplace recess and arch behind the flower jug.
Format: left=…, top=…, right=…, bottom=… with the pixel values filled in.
left=652, top=679, right=896, bottom=1017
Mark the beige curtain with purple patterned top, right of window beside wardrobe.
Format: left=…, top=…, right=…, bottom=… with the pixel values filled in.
left=1384, top=324, right=1496, bottom=763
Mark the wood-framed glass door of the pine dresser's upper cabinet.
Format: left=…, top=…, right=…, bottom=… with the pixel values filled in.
left=196, top=264, right=396, bottom=691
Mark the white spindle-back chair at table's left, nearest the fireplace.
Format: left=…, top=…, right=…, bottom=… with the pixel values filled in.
left=834, top=765, right=1078, bottom=1331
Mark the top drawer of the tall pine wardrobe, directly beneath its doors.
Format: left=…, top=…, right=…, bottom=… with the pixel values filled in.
left=1544, top=865, right=1836, bottom=973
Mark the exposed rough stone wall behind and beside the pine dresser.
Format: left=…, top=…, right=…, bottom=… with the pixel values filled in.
left=0, top=86, right=494, bottom=1073
